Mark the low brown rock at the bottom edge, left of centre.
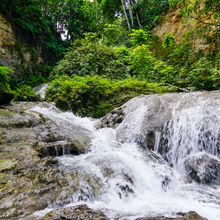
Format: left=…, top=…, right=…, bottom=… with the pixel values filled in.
left=41, top=205, right=108, bottom=220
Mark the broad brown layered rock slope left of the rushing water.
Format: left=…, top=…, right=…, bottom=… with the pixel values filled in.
left=0, top=103, right=93, bottom=219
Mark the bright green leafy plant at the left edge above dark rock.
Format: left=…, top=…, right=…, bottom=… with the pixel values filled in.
left=0, top=66, right=13, bottom=93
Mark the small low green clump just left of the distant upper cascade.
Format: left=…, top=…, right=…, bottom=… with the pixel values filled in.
left=12, top=86, right=40, bottom=102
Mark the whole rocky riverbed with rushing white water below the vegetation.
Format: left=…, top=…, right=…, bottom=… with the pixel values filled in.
left=0, top=92, right=219, bottom=220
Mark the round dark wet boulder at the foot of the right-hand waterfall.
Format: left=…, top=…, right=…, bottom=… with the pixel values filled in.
left=184, top=153, right=220, bottom=183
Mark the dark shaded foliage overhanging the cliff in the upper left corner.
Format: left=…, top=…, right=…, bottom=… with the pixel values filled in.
left=0, top=0, right=65, bottom=63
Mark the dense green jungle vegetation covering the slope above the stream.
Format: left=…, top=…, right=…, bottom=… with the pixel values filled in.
left=0, top=0, right=220, bottom=117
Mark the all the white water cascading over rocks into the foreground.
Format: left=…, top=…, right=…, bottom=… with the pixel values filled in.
left=34, top=92, right=220, bottom=220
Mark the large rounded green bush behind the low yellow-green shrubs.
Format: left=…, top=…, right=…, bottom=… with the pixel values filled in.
left=52, top=38, right=128, bottom=79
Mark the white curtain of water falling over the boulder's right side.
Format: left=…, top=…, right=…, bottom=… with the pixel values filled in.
left=156, top=93, right=220, bottom=169
